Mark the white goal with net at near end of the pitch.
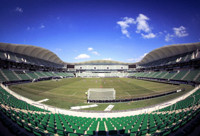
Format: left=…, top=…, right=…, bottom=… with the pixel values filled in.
left=88, top=88, right=115, bottom=100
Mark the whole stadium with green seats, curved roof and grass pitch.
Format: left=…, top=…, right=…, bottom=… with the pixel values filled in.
left=0, top=43, right=200, bottom=136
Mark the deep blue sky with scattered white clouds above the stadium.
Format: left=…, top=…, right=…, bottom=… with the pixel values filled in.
left=0, top=0, right=200, bottom=62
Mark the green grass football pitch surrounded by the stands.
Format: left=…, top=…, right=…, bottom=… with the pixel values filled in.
left=9, top=78, right=193, bottom=111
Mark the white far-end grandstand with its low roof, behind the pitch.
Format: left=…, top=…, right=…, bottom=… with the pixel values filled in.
left=75, top=60, right=128, bottom=77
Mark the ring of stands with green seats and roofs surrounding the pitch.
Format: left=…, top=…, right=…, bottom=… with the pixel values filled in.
left=0, top=43, right=200, bottom=136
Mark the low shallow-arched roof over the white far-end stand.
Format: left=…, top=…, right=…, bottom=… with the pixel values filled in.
left=74, top=60, right=129, bottom=65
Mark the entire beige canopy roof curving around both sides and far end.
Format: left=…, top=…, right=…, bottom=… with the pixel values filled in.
left=0, top=42, right=200, bottom=65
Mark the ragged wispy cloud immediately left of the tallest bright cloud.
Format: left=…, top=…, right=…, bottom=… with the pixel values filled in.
left=117, top=17, right=135, bottom=38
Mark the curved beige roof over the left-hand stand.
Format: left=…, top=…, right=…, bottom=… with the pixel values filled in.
left=0, top=43, right=64, bottom=64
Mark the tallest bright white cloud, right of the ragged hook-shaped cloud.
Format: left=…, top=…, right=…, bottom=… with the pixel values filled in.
left=136, top=14, right=151, bottom=33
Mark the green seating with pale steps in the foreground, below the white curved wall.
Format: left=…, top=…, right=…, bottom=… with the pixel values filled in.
left=0, top=85, right=200, bottom=136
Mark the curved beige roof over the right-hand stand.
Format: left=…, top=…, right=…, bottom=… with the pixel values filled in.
left=138, top=42, right=200, bottom=64
